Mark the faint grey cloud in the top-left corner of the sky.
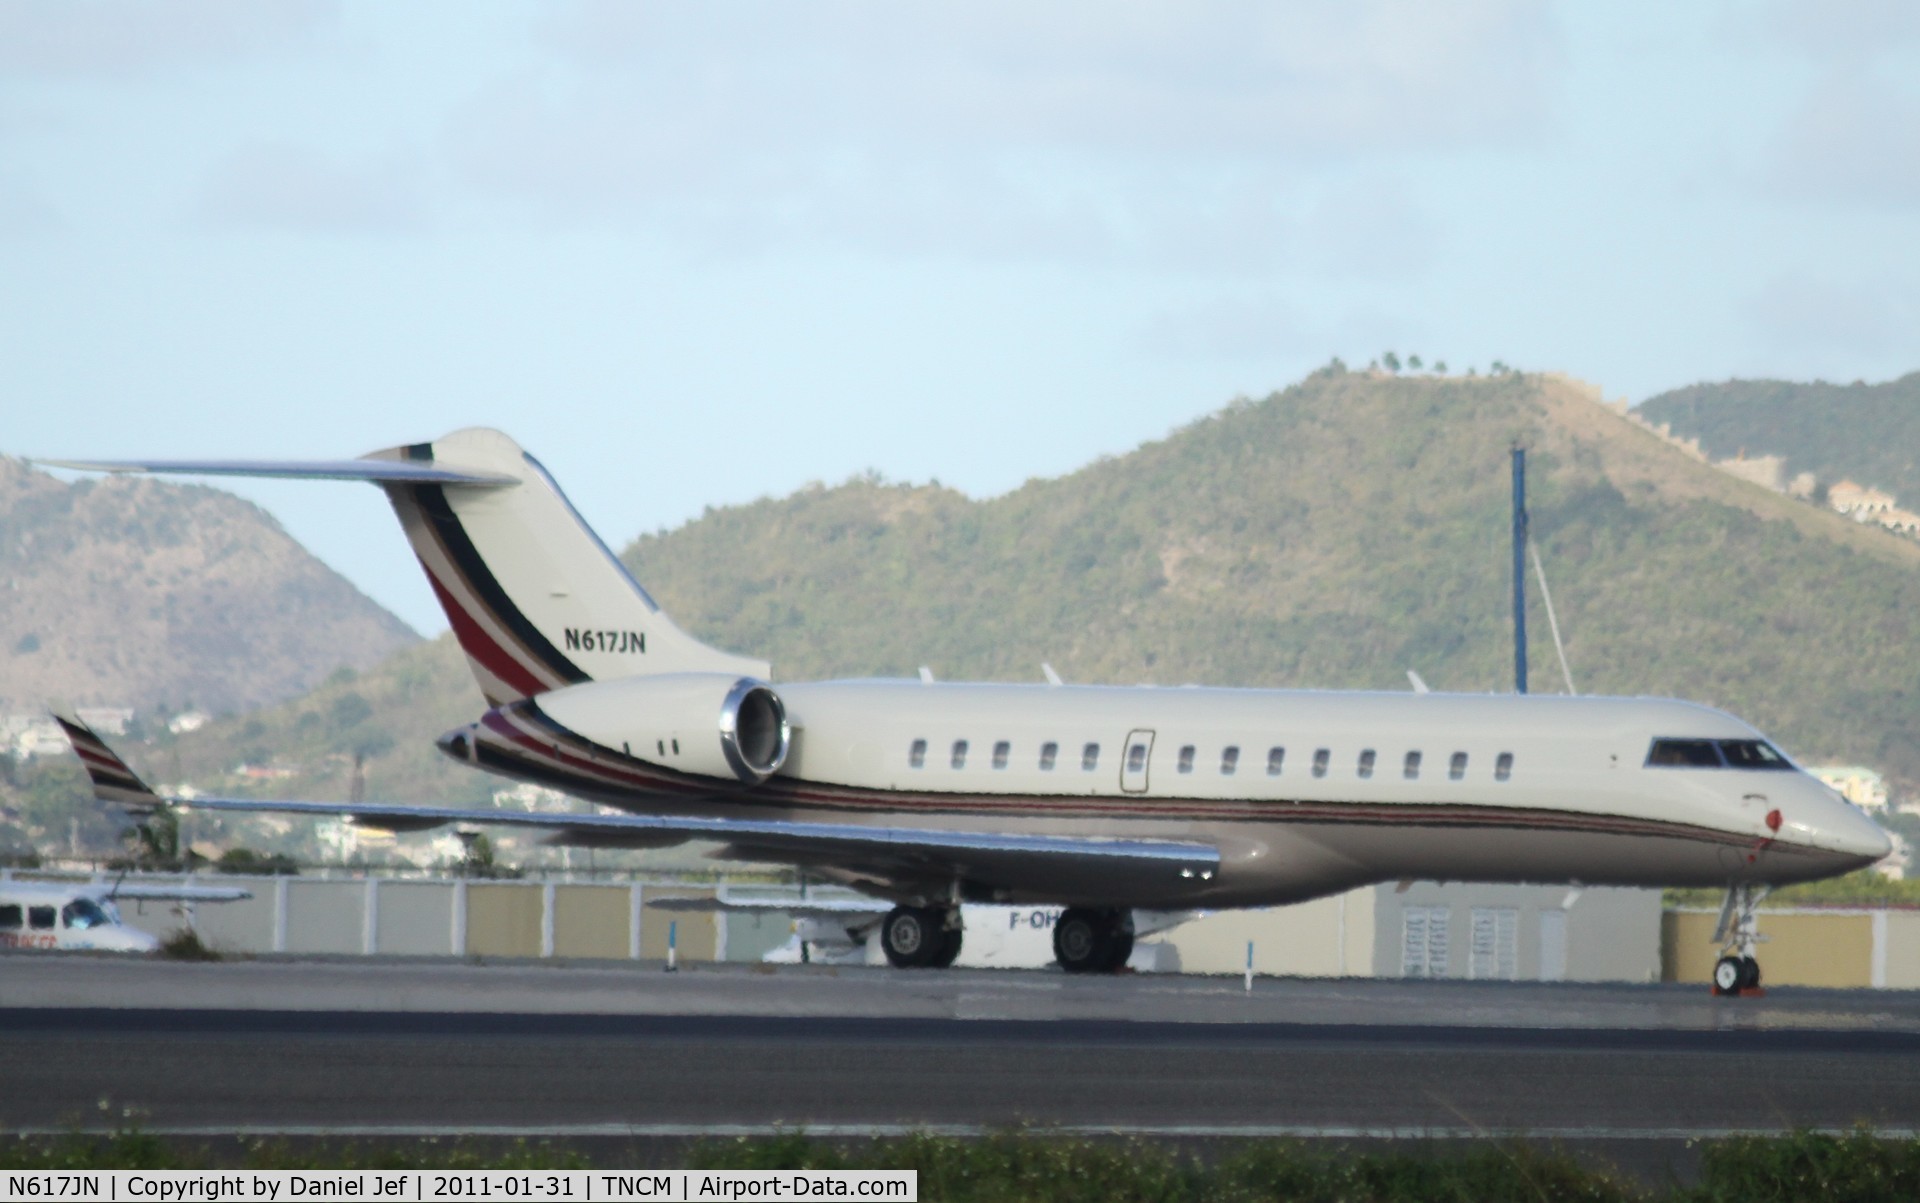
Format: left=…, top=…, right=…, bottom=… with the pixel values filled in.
left=0, top=0, right=340, bottom=79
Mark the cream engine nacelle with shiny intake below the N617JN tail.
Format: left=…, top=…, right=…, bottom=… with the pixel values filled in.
left=532, top=673, right=793, bottom=785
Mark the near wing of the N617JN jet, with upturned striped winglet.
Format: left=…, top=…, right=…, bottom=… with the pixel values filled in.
left=54, top=714, right=1219, bottom=898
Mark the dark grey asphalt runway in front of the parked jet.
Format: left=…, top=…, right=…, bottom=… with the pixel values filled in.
left=0, top=955, right=1920, bottom=1142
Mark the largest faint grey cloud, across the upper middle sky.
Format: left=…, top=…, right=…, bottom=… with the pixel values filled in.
left=447, top=0, right=1559, bottom=271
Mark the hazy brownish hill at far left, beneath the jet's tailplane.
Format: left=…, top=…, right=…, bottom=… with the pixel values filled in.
left=0, top=457, right=419, bottom=714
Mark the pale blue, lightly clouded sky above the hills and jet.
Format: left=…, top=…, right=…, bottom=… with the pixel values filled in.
left=0, top=0, right=1920, bottom=633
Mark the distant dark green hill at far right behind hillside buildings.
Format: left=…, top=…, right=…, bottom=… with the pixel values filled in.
left=1640, top=372, right=1920, bottom=508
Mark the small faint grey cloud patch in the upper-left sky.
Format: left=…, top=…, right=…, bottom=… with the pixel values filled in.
left=194, top=144, right=424, bottom=234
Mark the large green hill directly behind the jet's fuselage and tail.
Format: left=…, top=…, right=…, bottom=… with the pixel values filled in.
left=93, top=368, right=1920, bottom=867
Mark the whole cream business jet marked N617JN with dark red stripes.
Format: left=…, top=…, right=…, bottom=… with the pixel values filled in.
left=42, top=430, right=1889, bottom=990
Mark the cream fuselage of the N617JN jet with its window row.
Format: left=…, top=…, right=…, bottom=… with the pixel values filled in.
left=456, top=679, right=1887, bottom=908
